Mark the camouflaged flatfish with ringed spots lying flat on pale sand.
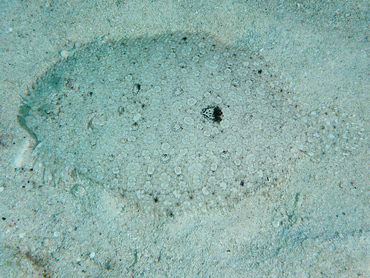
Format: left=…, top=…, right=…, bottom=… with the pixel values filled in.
left=19, top=32, right=362, bottom=216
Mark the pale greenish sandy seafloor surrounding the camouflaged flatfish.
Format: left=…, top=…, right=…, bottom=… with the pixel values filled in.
left=0, top=0, right=370, bottom=277
